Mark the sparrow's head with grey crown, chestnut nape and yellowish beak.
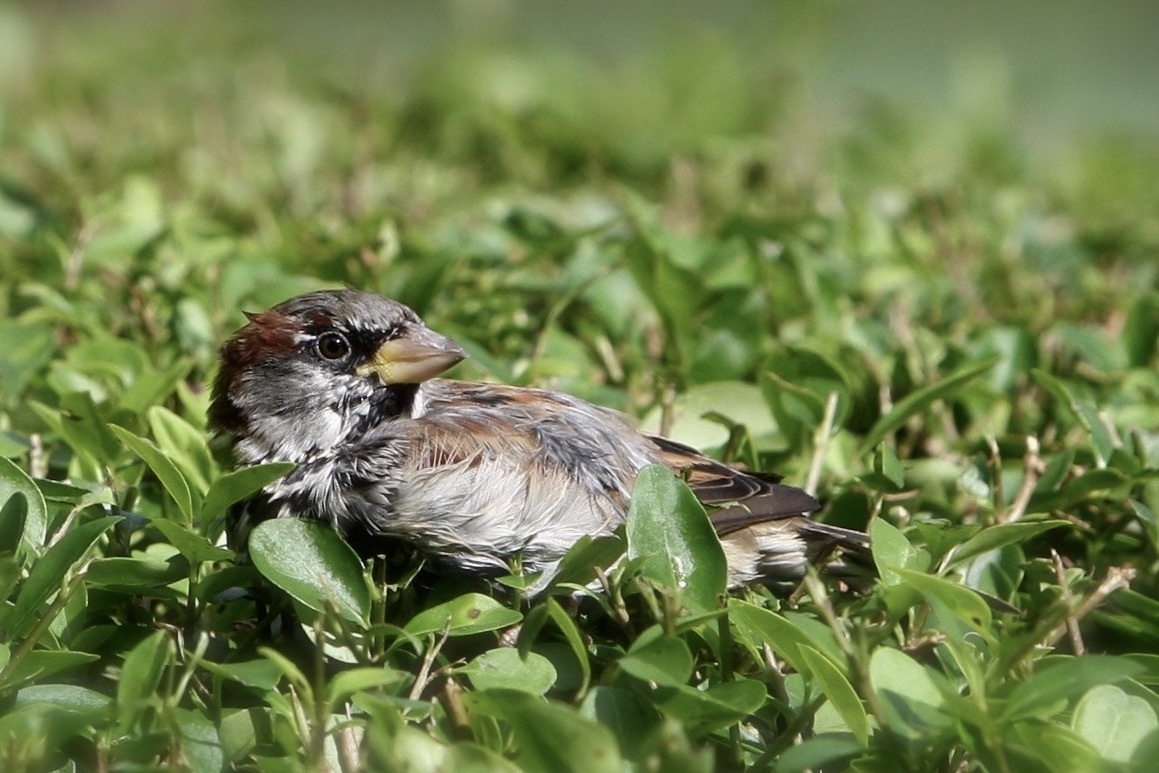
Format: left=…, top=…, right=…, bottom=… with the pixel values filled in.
left=209, top=290, right=466, bottom=461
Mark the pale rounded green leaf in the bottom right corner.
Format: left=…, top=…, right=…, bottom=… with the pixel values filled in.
left=1071, top=685, right=1159, bottom=763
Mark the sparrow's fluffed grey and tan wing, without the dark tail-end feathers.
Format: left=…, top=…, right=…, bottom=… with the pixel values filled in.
left=363, top=380, right=648, bottom=569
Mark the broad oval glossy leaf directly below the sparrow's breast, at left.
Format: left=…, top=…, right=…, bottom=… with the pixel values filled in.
left=249, top=518, right=370, bottom=627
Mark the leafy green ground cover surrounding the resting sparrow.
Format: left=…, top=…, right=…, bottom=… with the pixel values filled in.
left=0, top=3, right=1159, bottom=772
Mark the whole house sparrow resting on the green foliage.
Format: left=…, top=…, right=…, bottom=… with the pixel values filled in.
left=210, top=290, right=868, bottom=586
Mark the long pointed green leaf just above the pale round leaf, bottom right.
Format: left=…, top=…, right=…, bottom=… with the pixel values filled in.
left=1001, top=655, right=1144, bottom=722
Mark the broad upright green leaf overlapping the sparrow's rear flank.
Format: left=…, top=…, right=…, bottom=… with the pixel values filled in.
left=627, top=465, right=728, bottom=612
